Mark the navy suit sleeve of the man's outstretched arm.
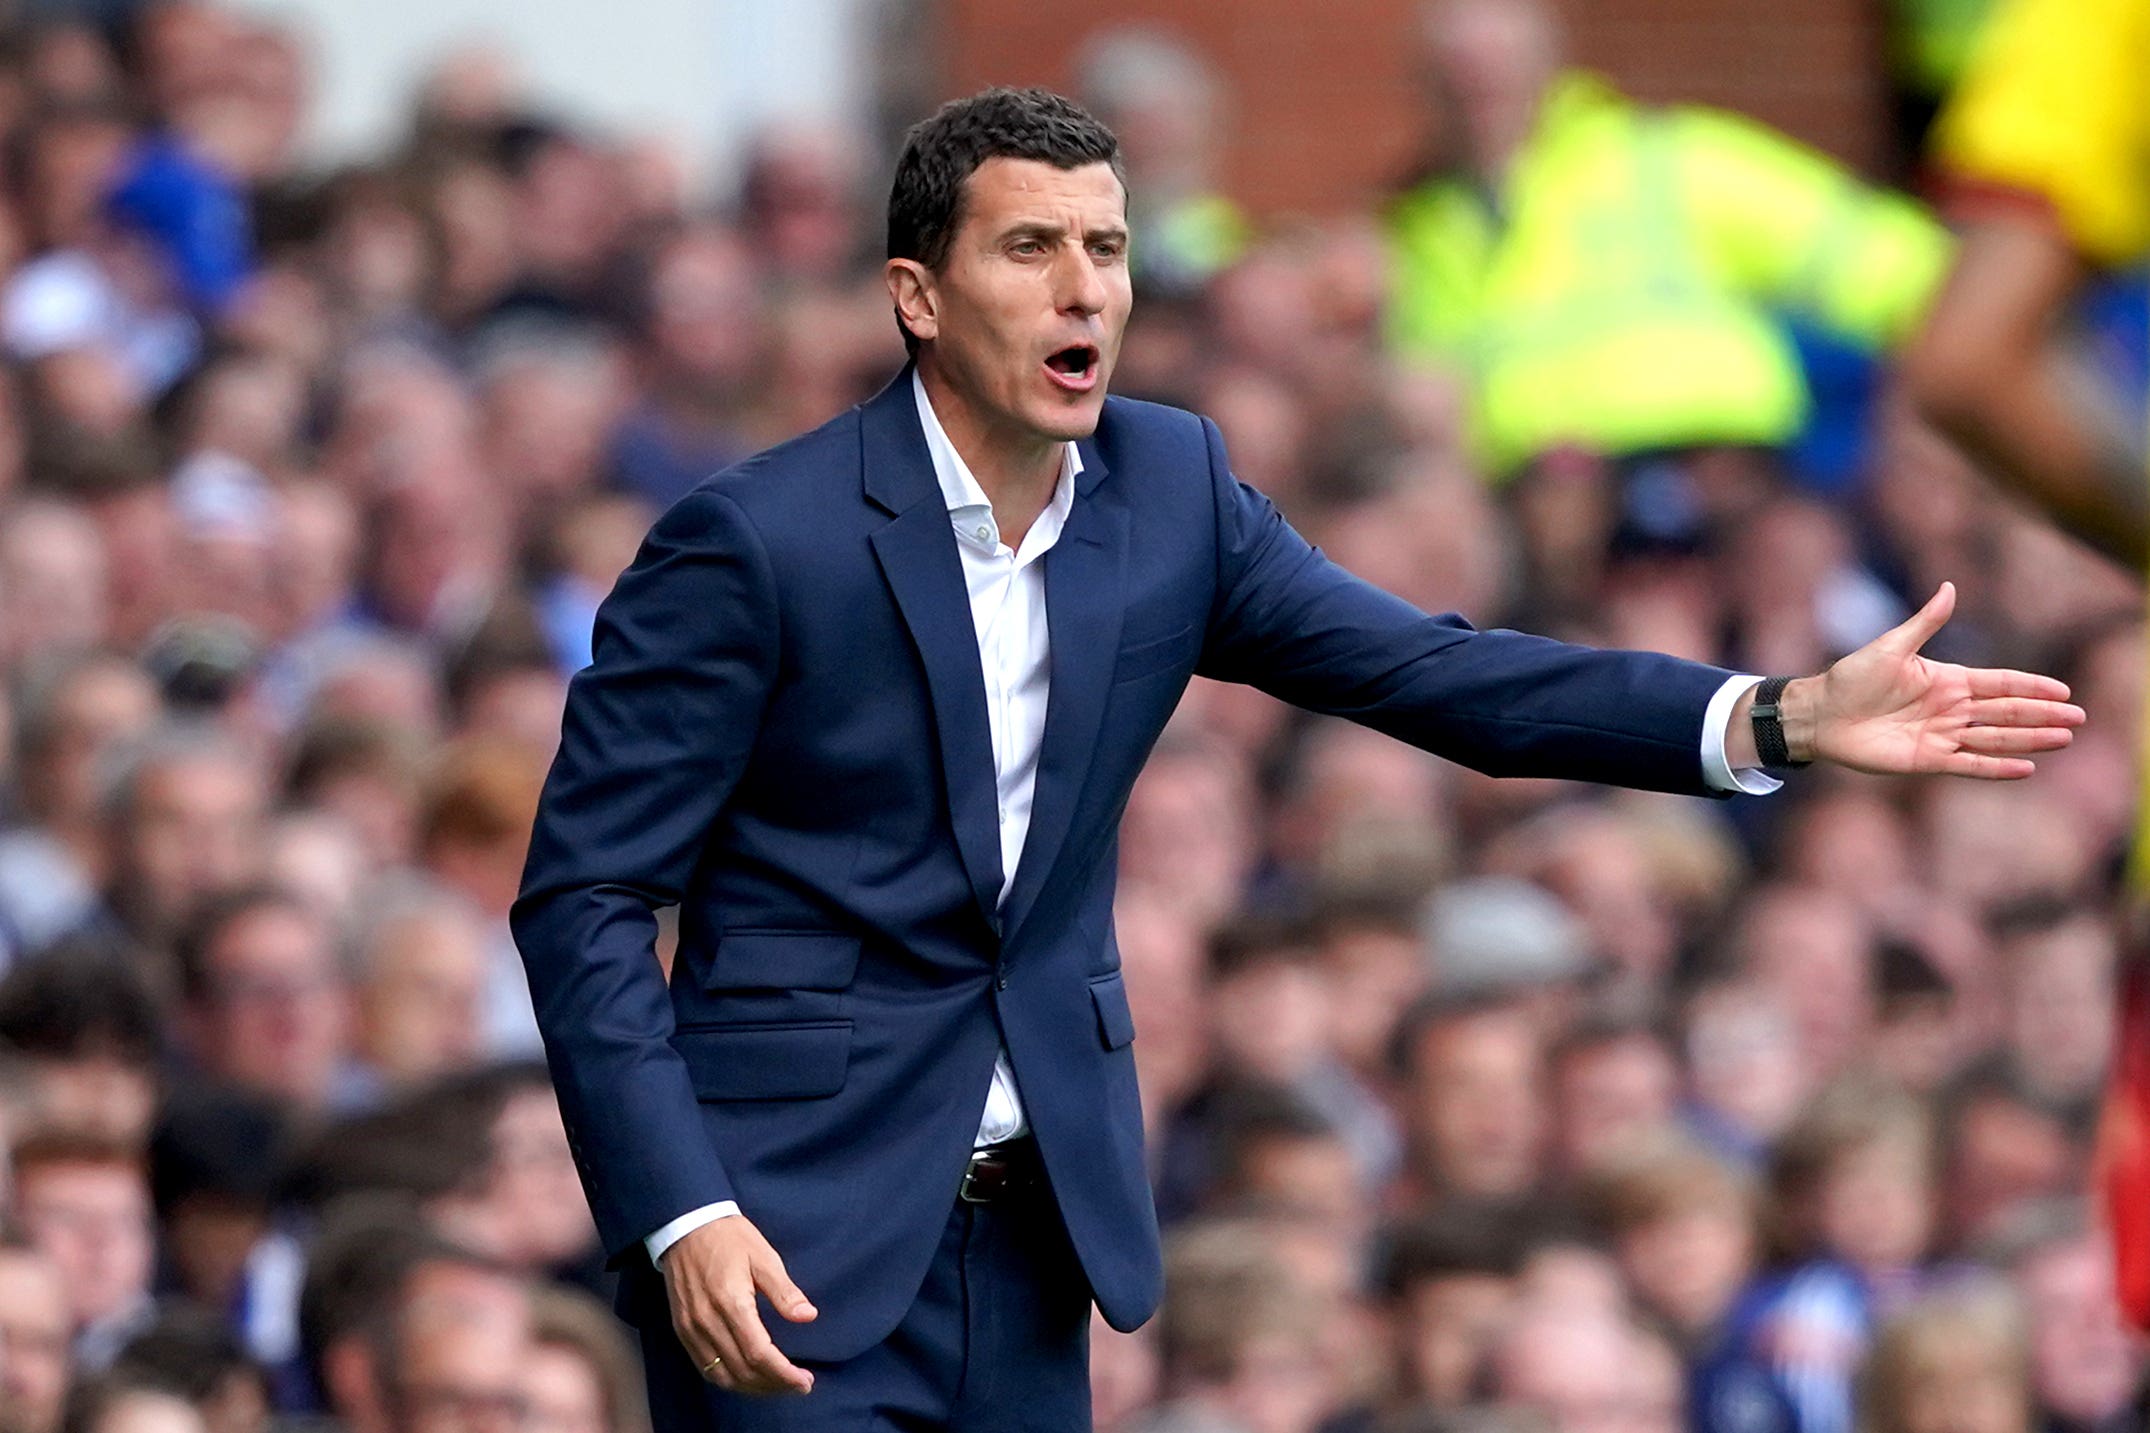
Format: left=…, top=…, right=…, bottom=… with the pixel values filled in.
left=1198, top=419, right=1731, bottom=795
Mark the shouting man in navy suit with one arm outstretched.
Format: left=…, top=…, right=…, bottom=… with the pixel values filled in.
left=514, top=90, right=2081, bottom=1433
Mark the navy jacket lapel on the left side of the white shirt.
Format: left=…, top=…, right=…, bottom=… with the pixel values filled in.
left=860, top=367, right=1002, bottom=930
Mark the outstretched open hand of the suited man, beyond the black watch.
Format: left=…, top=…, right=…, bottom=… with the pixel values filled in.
left=1782, top=582, right=2083, bottom=782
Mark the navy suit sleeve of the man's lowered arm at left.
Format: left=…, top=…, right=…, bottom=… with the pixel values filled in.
left=510, top=490, right=778, bottom=1261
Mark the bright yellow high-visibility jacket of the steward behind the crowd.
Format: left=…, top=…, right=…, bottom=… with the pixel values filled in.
left=1387, top=73, right=1950, bottom=475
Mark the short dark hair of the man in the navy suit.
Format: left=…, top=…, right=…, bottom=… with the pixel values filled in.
left=888, top=86, right=1127, bottom=352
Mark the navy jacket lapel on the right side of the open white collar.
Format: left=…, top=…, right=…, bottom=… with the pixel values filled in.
left=1002, top=443, right=1129, bottom=939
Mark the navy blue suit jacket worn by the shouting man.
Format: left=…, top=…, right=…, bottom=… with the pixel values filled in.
left=514, top=374, right=1726, bottom=1358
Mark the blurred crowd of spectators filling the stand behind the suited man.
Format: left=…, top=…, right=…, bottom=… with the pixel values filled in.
left=0, top=0, right=2144, bottom=1433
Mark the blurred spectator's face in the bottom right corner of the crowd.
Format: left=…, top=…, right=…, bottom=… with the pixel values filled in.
left=2017, top=1235, right=2144, bottom=1427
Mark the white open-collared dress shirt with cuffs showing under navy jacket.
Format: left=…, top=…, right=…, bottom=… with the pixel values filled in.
left=645, top=372, right=1780, bottom=1259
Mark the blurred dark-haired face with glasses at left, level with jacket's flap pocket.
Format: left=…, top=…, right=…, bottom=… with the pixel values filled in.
left=191, top=902, right=348, bottom=1109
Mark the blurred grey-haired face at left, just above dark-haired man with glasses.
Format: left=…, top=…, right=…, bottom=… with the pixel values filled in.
left=118, top=752, right=269, bottom=930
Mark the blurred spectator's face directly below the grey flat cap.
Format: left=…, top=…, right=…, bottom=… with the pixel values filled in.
left=1406, top=1005, right=1546, bottom=1197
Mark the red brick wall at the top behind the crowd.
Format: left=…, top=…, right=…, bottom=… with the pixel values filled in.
left=933, top=0, right=1883, bottom=215
